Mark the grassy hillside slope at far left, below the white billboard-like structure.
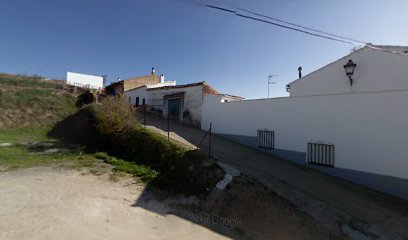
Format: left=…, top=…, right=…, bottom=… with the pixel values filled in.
left=0, top=74, right=76, bottom=128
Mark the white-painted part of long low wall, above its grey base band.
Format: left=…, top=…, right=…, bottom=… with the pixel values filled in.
left=201, top=90, right=408, bottom=179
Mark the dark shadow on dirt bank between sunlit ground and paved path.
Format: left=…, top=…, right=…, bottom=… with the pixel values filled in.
left=132, top=173, right=336, bottom=239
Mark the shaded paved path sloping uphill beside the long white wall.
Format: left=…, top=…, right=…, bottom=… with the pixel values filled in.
left=138, top=115, right=408, bottom=239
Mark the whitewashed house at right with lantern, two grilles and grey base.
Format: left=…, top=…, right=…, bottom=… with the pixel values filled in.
left=201, top=45, right=408, bottom=199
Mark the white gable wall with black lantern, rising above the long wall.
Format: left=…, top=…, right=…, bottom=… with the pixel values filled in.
left=290, top=47, right=408, bottom=96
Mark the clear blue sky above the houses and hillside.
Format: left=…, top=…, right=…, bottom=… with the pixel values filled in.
left=0, top=0, right=408, bottom=98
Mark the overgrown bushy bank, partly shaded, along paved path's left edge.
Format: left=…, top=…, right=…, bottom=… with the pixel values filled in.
left=54, top=97, right=223, bottom=195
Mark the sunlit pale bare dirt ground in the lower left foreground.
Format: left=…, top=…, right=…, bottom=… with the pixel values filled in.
left=0, top=167, right=227, bottom=240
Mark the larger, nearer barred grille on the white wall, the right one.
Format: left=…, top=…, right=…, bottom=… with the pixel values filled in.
left=307, top=143, right=334, bottom=167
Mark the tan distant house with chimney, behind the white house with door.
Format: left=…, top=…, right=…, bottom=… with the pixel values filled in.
left=105, top=68, right=161, bottom=96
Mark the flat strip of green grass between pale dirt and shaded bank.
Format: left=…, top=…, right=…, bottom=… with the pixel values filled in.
left=0, top=127, right=159, bottom=183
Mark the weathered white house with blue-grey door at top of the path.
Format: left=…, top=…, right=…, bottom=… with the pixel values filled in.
left=125, top=82, right=243, bottom=126
